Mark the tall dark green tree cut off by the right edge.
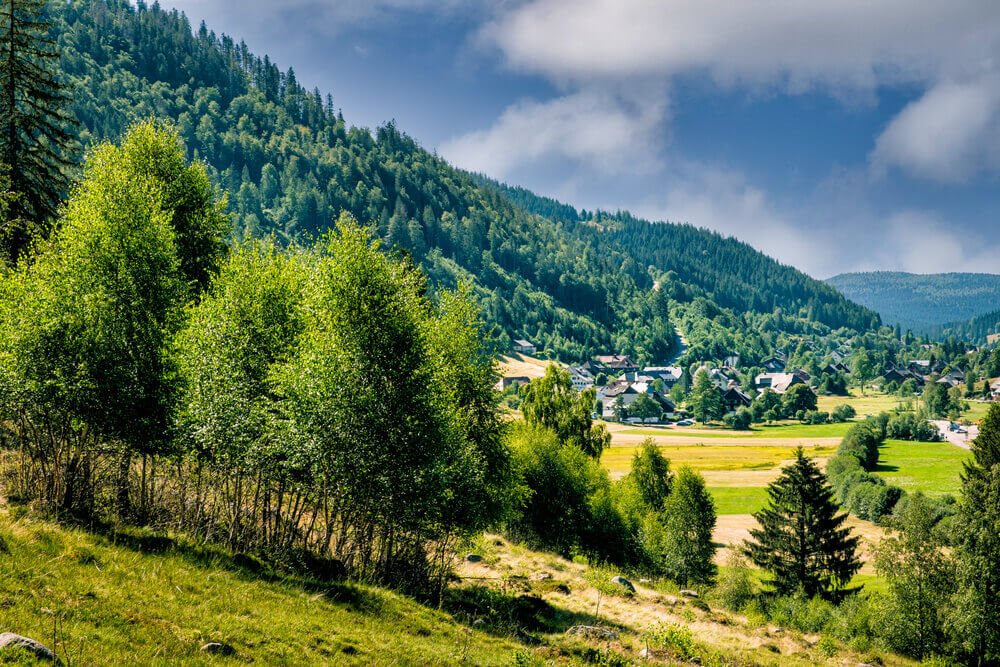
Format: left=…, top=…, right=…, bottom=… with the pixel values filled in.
left=951, top=404, right=1000, bottom=665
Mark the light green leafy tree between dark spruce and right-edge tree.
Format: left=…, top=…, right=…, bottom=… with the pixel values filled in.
left=875, top=493, right=955, bottom=658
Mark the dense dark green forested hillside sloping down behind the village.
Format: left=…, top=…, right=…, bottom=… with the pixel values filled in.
left=58, top=0, right=878, bottom=362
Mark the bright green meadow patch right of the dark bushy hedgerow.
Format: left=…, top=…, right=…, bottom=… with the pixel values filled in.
left=875, top=440, right=970, bottom=495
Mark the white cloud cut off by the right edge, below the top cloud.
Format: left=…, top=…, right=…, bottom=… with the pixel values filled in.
left=871, top=75, right=1000, bottom=182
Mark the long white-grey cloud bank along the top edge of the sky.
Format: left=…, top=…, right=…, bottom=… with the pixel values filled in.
left=481, top=0, right=1000, bottom=88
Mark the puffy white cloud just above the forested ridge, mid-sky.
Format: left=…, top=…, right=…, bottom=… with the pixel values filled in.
left=439, top=89, right=667, bottom=178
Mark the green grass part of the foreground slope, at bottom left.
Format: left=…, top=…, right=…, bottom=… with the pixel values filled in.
left=0, top=513, right=518, bottom=665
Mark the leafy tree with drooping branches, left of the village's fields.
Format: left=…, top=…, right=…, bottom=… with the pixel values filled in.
left=521, top=364, right=611, bottom=459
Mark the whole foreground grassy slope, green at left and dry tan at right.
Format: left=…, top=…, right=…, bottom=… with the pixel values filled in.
left=0, top=511, right=905, bottom=665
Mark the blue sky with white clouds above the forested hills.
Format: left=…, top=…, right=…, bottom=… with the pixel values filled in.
left=161, top=0, right=1000, bottom=278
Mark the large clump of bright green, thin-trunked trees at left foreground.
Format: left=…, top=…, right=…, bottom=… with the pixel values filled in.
left=0, top=123, right=518, bottom=592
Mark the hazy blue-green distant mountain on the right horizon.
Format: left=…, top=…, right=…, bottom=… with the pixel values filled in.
left=827, top=271, right=1000, bottom=334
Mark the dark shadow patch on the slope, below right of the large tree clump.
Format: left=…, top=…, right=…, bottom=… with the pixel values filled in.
left=441, top=585, right=624, bottom=644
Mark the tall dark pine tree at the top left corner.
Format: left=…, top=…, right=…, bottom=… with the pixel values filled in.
left=0, top=0, right=75, bottom=261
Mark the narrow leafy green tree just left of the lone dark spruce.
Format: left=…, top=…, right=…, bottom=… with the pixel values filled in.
left=663, top=466, right=717, bottom=586
